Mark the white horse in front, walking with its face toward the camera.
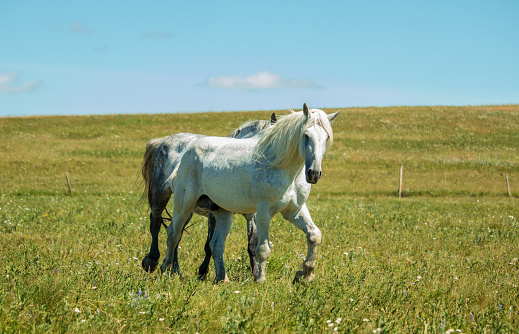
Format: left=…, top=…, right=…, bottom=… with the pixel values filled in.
left=161, top=104, right=339, bottom=282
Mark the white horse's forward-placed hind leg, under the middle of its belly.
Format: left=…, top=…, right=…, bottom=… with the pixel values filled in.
left=210, top=209, right=232, bottom=283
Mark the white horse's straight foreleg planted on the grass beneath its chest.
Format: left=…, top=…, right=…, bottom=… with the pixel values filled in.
left=256, top=205, right=272, bottom=283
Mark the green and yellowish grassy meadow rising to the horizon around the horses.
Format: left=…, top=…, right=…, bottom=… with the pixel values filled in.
left=0, top=105, right=519, bottom=333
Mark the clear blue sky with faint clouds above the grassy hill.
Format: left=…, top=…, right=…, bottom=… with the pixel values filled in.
left=0, top=0, right=519, bottom=116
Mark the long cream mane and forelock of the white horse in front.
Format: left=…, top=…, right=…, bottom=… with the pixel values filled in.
left=254, top=109, right=333, bottom=168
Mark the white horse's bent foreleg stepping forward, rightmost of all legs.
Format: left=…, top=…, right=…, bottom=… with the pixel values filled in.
left=283, top=204, right=321, bottom=283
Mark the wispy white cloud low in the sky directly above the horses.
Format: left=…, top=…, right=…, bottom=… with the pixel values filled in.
left=203, top=71, right=321, bottom=90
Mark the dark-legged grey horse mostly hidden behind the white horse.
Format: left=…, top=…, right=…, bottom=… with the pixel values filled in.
left=138, top=113, right=276, bottom=279
